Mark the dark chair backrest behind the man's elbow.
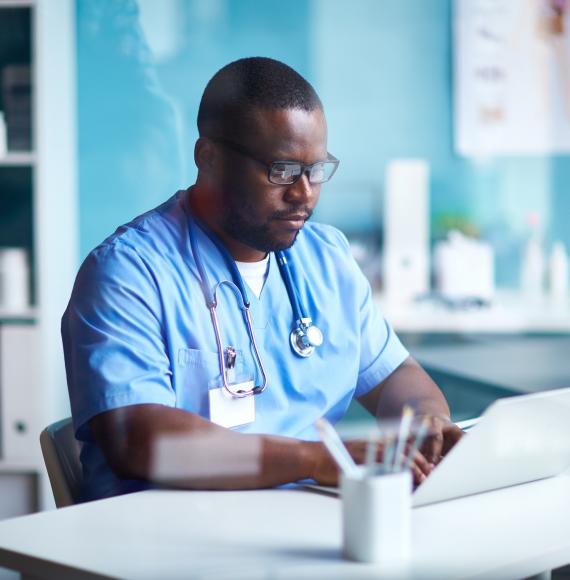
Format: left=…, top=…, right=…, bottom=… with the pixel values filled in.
left=40, top=418, right=83, bottom=508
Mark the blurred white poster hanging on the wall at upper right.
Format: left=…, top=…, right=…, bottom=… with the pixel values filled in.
left=454, top=0, right=570, bottom=156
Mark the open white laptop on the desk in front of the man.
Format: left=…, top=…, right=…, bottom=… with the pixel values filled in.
left=307, top=388, right=570, bottom=507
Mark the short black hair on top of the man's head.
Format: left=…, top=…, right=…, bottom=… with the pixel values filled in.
left=198, top=56, right=323, bottom=137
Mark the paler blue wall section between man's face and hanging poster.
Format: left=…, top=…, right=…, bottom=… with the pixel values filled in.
left=314, top=0, right=560, bottom=286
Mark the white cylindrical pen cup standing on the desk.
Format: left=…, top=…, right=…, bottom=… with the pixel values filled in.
left=341, top=466, right=412, bottom=573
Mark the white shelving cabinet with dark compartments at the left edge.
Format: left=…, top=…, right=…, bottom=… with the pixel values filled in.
left=0, top=0, right=77, bottom=518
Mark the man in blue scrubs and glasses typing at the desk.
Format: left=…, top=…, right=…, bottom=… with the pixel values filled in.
left=62, top=58, right=460, bottom=499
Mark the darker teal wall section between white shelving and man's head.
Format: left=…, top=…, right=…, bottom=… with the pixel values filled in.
left=77, top=0, right=311, bottom=257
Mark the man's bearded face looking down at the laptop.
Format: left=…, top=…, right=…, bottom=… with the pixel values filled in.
left=214, top=109, right=327, bottom=253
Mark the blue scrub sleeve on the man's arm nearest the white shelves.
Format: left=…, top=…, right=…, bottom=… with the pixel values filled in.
left=62, top=241, right=176, bottom=440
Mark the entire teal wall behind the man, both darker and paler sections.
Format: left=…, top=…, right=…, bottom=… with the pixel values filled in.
left=77, top=0, right=570, bottom=285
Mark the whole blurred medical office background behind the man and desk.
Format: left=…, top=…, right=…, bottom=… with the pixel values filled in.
left=0, top=0, right=570, bottom=577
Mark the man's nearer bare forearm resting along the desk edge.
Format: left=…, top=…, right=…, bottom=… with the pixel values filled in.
left=91, top=405, right=318, bottom=489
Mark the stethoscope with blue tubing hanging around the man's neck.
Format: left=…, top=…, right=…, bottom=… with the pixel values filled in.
left=188, top=218, right=323, bottom=398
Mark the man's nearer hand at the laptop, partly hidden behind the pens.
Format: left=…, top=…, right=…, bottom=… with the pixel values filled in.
left=312, top=440, right=432, bottom=486
